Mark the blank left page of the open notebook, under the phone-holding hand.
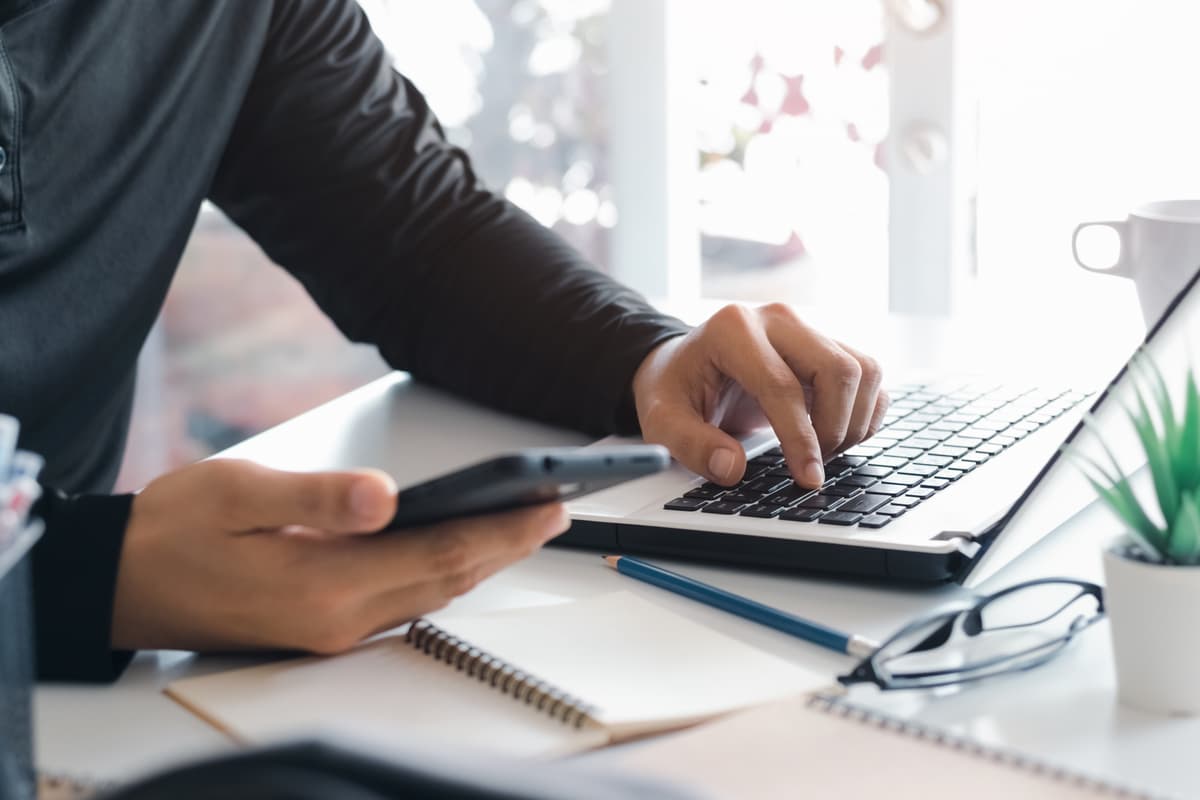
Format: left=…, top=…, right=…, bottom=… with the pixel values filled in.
left=167, top=637, right=608, bottom=757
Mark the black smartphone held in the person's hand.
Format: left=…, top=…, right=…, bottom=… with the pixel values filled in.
left=386, top=445, right=671, bottom=530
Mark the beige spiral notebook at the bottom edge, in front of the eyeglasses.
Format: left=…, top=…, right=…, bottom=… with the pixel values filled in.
left=617, top=693, right=1159, bottom=800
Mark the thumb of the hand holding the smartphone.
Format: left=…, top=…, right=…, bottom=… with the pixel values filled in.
left=206, top=461, right=396, bottom=533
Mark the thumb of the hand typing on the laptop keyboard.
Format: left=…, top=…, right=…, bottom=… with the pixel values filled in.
left=642, top=403, right=746, bottom=486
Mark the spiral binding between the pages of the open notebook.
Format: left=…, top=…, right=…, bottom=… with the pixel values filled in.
left=404, top=619, right=596, bottom=728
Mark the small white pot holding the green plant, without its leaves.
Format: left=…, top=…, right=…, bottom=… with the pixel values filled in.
left=1104, top=545, right=1200, bottom=716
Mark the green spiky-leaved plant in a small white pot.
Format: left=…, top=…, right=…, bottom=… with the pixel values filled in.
left=1084, top=356, right=1200, bottom=715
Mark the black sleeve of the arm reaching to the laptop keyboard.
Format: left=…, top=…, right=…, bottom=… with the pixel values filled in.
left=211, top=0, right=686, bottom=433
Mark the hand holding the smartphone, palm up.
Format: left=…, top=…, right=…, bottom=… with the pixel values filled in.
left=112, top=461, right=569, bottom=652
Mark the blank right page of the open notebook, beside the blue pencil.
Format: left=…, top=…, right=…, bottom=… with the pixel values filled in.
left=438, top=591, right=829, bottom=736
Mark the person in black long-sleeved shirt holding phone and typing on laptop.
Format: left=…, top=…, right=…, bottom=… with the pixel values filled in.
left=0, top=0, right=887, bottom=680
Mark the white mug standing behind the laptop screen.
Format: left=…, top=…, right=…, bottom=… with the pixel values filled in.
left=1070, top=200, right=1200, bottom=329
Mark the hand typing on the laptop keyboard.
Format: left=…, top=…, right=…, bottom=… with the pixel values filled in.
left=634, top=303, right=888, bottom=488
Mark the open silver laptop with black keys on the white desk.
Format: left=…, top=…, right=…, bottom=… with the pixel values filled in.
left=559, top=271, right=1200, bottom=585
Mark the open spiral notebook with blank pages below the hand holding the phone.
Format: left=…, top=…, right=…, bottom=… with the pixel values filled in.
left=167, top=591, right=828, bottom=756
